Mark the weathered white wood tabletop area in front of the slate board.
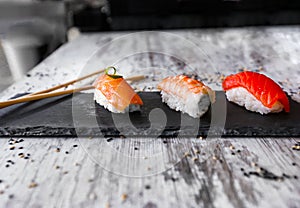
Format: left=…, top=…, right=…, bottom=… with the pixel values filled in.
left=0, top=138, right=300, bottom=207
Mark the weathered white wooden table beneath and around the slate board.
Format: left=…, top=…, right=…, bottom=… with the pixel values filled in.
left=0, top=27, right=300, bottom=208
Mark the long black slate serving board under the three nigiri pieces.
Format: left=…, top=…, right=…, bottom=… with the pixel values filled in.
left=0, top=91, right=300, bottom=137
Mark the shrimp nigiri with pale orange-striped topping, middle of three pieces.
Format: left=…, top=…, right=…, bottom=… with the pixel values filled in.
left=158, top=75, right=215, bottom=118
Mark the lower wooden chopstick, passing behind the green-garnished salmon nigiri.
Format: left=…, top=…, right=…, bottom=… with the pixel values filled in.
left=0, top=75, right=145, bottom=108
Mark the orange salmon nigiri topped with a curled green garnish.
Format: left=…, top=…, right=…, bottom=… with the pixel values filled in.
left=94, top=67, right=143, bottom=113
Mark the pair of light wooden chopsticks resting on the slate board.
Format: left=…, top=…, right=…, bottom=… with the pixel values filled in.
left=0, top=69, right=145, bottom=108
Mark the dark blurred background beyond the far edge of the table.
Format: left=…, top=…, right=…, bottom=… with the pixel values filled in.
left=0, top=0, right=300, bottom=91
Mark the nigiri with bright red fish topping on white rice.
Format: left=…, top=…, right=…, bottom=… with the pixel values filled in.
left=222, top=71, right=290, bottom=114
